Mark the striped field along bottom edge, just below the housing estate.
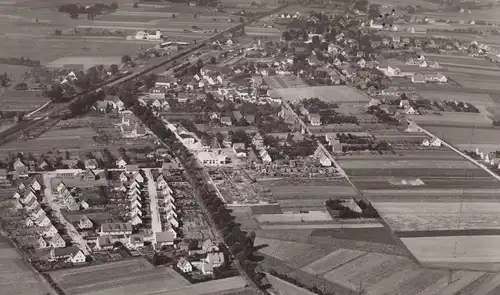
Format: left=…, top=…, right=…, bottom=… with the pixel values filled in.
left=50, top=259, right=245, bottom=295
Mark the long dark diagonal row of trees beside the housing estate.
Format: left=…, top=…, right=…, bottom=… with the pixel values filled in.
left=119, top=83, right=270, bottom=292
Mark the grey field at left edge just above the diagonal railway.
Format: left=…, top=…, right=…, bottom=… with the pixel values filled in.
left=0, top=90, right=50, bottom=112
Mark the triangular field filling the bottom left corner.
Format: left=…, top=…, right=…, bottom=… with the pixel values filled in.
left=0, top=236, right=55, bottom=295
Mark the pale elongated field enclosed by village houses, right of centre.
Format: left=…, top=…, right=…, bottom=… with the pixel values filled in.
left=271, top=86, right=368, bottom=103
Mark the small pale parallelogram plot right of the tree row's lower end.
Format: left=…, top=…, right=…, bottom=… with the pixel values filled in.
left=302, top=249, right=366, bottom=275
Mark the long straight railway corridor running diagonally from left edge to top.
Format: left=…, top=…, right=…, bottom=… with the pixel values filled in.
left=0, top=4, right=288, bottom=145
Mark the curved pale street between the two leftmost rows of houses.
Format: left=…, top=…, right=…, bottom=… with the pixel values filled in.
left=43, top=173, right=90, bottom=255
